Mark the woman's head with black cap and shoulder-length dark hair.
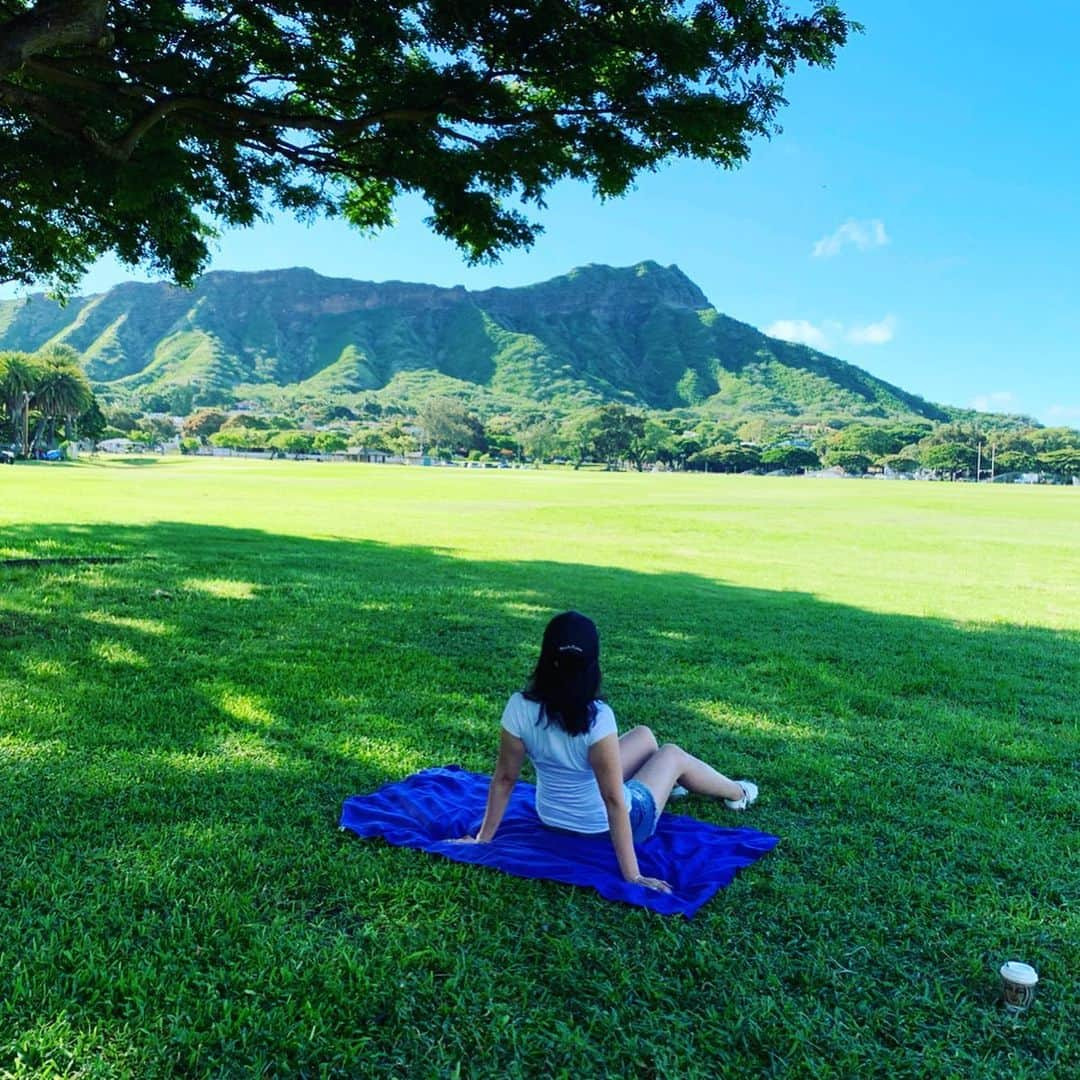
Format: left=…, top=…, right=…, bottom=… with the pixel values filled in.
left=522, top=611, right=600, bottom=735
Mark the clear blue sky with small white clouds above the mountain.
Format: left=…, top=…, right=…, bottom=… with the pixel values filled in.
left=10, top=0, right=1080, bottom=427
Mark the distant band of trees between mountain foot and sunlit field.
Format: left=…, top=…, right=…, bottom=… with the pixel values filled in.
left=67, top=386, right=1080, bottom=480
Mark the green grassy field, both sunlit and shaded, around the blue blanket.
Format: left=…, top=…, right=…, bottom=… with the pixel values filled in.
left=0, top=459, right=1080, bottom=1078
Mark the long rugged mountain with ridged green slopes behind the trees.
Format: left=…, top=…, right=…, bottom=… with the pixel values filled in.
left=0, top=262, right=947, bottom=419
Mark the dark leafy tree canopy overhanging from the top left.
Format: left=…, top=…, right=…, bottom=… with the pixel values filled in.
left=0, top=0, right=856, bottom=289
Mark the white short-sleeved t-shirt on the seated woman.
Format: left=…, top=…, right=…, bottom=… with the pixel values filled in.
left=502, top=693, right=618, bottom=833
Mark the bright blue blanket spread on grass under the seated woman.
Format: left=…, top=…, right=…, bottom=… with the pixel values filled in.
left=340, top=765, right=779, bottom=918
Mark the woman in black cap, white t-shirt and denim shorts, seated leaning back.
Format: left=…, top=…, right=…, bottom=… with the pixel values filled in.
left=461, top=611, right=757, bottom=892
